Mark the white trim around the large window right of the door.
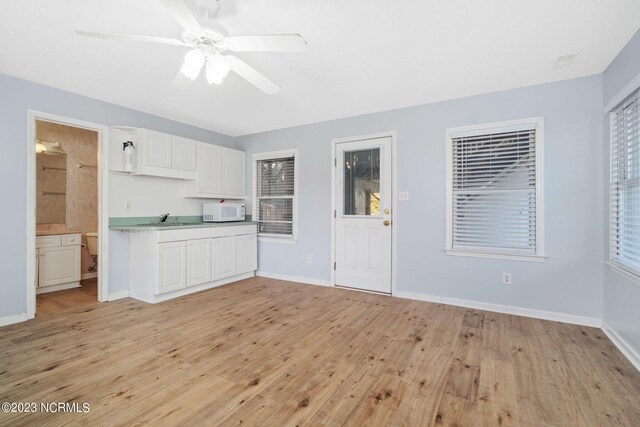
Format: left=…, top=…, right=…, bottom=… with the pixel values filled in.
left=444, top=117, right=547, bottom=262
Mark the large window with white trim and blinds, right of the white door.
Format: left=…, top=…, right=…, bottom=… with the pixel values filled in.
left=446, top=118, right=544, bottom=261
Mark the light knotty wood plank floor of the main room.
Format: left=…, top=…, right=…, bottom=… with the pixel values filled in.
left=0, top=278, right=640, bottom=426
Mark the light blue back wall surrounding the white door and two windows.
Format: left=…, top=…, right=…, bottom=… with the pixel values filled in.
left=236, top=75, right=603, bottom=318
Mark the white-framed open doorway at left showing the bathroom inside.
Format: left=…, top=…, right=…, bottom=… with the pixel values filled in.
left=27, top=111, right=108, bottom=318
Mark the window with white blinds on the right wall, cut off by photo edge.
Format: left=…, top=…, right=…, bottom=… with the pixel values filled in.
left=609, top=90, right=640, bottom=276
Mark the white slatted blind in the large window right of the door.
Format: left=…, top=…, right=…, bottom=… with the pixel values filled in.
left=451, top=125, right=537, bottom=255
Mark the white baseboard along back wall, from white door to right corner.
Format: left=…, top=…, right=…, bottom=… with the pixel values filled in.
left=394, top=291, right=602, bottom=328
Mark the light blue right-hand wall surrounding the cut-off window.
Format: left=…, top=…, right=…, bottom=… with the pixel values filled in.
left=602, top=32, right=640, bottom=354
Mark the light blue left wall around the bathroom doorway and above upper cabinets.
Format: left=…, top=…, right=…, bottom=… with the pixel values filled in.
left=0, top=74, right=234, bottom=318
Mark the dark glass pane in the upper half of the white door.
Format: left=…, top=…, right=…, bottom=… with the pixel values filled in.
left=343, top=148, right=380, bottom=216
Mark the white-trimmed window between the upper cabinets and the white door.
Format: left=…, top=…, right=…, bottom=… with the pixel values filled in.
left=253, top=150, right=297, bottom=240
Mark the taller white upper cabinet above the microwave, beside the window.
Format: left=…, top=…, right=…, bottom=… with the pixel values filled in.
left=183, top=142, right=247, bottom=199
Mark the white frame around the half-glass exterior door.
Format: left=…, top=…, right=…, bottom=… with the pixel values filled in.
left=329, top=130, right=398, bottom=296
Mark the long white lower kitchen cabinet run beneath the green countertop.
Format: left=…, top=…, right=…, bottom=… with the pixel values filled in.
left=129, top=224, right=257, bottom=303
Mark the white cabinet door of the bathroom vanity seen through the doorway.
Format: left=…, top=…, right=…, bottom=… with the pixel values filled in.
left=38, top=245, right=80, bottom=287
